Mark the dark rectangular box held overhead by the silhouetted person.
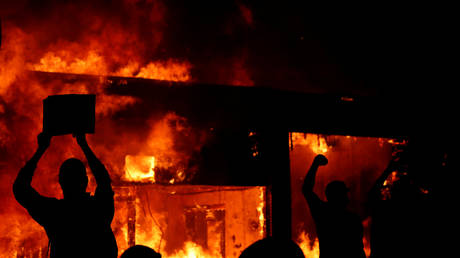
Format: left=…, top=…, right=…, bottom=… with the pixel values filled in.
left=43, top=94, right=96, bottom=136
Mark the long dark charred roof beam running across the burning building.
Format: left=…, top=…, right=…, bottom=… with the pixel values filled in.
left=25, top=69, right=420, bottom=138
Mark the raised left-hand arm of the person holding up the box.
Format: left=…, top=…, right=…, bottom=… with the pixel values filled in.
left=13, top=133, right=51, bottom=209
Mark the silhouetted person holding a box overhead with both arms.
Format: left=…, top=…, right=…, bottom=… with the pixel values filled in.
left=13, top=133, right=118, bottom=258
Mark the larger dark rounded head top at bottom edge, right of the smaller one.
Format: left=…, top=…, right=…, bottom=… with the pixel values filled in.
left=239, top=237, right=305, bottom=258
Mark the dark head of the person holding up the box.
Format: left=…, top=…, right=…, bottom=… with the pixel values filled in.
left=59, top=158, right=88, bottom=198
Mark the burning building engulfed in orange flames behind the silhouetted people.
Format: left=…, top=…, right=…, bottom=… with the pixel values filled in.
left=0, top=0, right=452, bottom=257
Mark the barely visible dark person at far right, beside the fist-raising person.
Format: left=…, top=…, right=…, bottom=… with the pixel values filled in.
left=369, top=157, right=433, bottom=258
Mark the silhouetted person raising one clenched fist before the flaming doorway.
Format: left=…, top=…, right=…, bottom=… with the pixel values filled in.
left=302, top=155, right=366, bottom=258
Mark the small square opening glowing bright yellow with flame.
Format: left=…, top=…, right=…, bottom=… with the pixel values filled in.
left=125, top=155, right=155, bottom=183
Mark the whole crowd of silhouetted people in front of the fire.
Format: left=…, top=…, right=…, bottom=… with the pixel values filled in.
left=13, top=133, right=435, bottom=258
